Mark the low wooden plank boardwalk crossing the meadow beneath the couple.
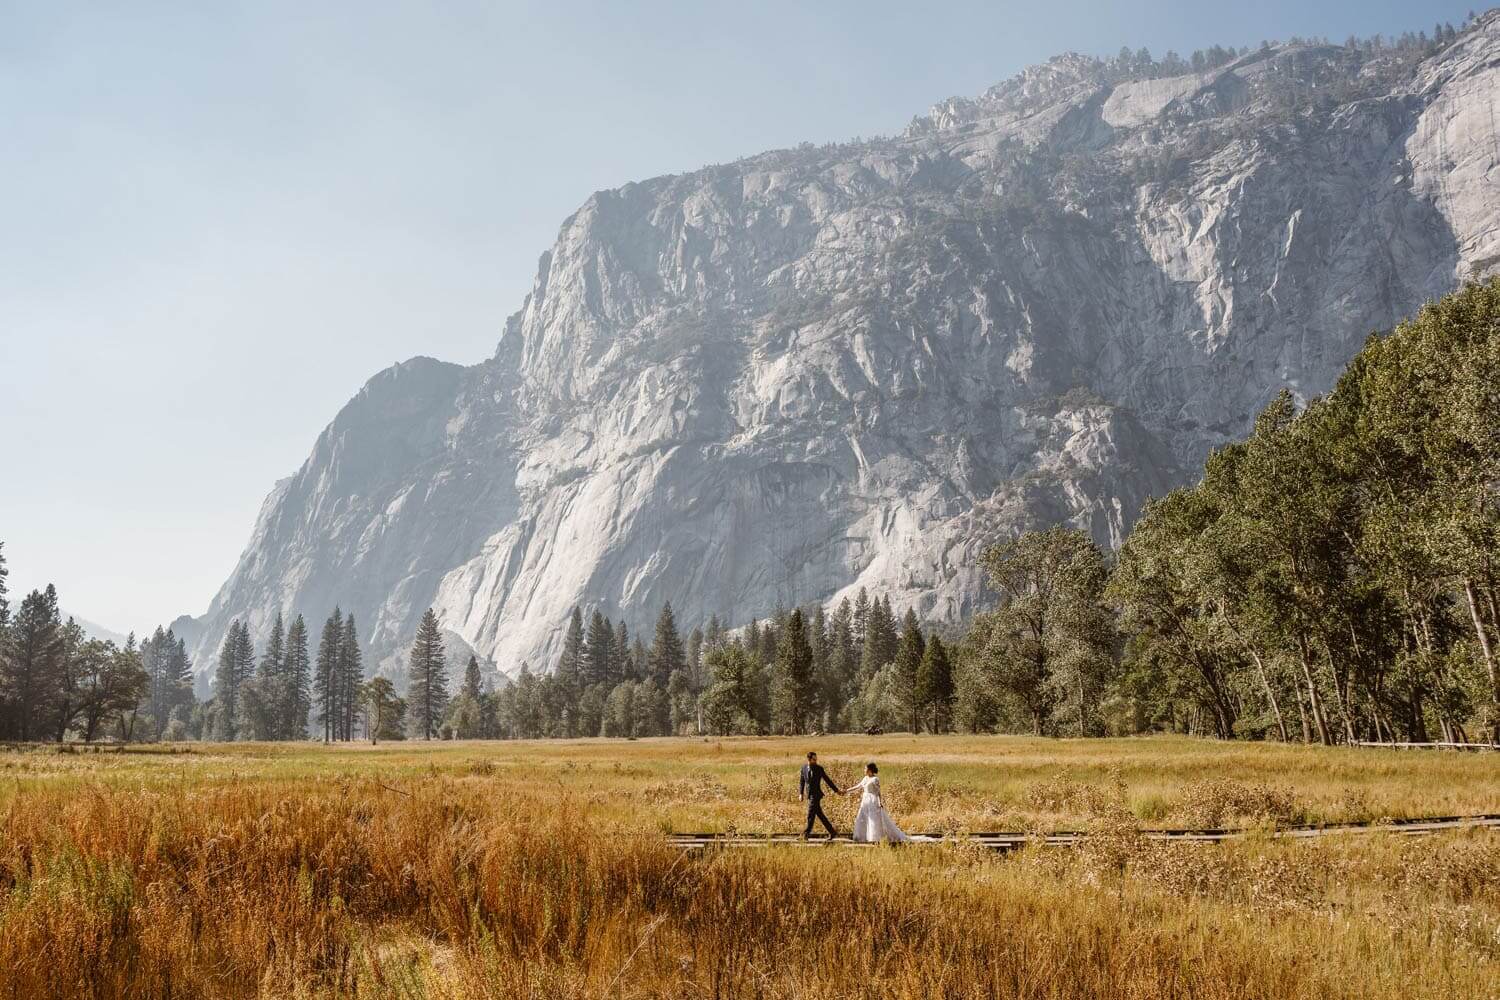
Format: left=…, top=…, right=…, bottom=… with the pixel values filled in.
left=668, top=813, right=1500, bottom=852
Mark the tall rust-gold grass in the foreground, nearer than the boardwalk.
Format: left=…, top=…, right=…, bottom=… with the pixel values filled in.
left=0, top=766, right=1500, bottom=1000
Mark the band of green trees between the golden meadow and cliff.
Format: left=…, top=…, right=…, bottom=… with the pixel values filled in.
left=0, top=280, right=1500, bottom=744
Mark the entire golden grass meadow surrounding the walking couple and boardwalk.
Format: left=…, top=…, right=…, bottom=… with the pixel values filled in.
left=0, top=736, right=1500, bottom=999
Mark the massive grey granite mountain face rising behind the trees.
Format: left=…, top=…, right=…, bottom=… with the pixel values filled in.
left=183, top=13, right=1500, bottom=692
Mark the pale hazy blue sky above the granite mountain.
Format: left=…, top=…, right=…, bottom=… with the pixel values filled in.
left=0, top=0, right=1470, bottom=633
